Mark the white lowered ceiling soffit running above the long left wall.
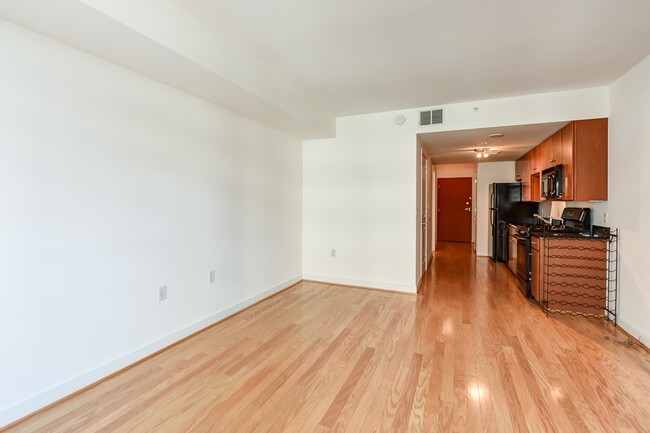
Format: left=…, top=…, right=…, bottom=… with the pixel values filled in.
left=0, top=0, right=335, bottom=139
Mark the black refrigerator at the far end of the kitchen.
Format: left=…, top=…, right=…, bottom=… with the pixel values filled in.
left=488, top=183, right=539, bottom=262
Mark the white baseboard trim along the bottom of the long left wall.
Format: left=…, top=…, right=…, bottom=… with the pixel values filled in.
left=0, top=275, right=302, bottom=432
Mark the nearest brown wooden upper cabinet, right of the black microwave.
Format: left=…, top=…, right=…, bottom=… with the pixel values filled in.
left=559, top=119, right=607, bottom=201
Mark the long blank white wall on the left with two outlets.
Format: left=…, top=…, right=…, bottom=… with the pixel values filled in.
left=0, top=21, right=302, bottom=426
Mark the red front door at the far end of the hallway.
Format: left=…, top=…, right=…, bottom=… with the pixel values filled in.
left=438, top=177, right=472, bottom=242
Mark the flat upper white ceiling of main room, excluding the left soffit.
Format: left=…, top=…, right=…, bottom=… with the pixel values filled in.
left=177, top=0, right=650, bottom=116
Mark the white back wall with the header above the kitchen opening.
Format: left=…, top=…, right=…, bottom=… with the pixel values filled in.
left=303, top=87, right=609, bottom=292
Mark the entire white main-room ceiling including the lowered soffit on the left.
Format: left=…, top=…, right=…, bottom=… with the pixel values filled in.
left=0, top=0, right=650, bottom=139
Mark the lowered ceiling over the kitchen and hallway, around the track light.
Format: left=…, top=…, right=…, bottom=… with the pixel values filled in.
left=418, top=122, right=567, bottom=164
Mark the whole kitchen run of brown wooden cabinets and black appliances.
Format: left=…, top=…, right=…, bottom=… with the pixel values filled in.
left=488, top=119, right=618, bottom=321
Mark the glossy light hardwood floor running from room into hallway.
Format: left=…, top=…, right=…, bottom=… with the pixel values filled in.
left=9, top=243, right=650, bottom=433
